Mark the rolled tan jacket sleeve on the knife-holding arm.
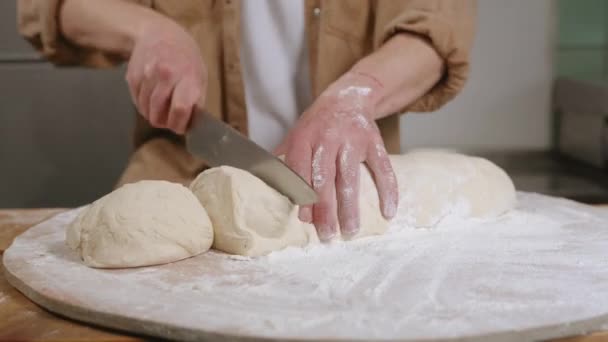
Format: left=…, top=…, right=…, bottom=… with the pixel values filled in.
left=17, top=0, right=152, bottom=68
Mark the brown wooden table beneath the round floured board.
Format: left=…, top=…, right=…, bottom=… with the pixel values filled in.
left=0, top=206, right=608, bottom=342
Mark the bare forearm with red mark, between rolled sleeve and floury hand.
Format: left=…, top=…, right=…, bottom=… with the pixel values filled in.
left=351, top=33, right=444, bottom=119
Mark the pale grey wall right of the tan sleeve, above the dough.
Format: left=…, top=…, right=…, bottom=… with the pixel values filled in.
left=401, top=0, right=555, bottom=150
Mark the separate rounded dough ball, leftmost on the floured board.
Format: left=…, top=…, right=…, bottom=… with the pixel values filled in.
left=66, top=181, right=213, bottom=268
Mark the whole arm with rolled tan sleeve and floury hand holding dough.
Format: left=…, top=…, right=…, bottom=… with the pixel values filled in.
left=278, top=0, right=475, bottom=240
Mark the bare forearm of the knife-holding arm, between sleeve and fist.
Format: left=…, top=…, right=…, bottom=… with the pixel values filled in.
left=59, top=0, right=170, bottom=58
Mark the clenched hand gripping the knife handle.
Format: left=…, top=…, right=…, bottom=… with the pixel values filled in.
left=126, top=21, right=207, bottom=134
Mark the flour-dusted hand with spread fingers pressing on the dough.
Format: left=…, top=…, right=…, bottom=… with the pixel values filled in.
left=277, top=73, right=398, bottom=240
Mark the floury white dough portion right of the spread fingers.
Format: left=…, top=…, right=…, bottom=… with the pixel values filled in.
left=391, top=150, right=515, bottom=227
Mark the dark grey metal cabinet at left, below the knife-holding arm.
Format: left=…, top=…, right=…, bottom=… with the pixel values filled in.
left=0, top=1, right=134, bottom=208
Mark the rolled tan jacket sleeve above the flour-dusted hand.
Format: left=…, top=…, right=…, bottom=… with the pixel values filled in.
left=374, top=0, right=476, bottom=112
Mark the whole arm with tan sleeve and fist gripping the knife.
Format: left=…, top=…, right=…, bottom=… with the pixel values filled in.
left=18, top=0, right=207, bottom=133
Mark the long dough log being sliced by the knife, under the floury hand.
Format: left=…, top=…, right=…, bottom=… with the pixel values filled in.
left=190, top=151, right=515, bottom=256
